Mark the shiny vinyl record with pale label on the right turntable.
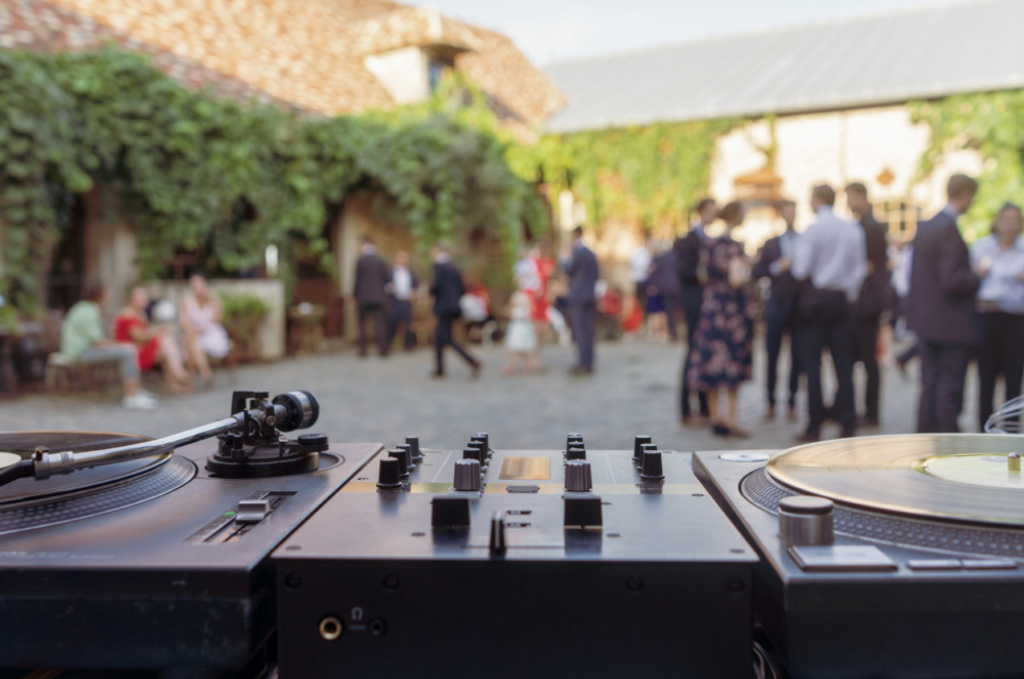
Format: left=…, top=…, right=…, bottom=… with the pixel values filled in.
left=766, top=434, right=1024, bottom=526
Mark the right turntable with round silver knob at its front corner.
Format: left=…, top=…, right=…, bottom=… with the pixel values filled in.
left=693, top=434, right=1024, bottom=679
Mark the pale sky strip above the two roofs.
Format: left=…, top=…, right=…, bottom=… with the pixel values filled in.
left=406, top=0, right=978, bottom=67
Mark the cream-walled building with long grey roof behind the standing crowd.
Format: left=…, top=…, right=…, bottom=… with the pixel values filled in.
left=546, top=0, right=1024, bottom=276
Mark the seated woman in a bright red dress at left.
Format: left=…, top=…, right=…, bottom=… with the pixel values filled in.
left=114, top=286, right=191, bottom=393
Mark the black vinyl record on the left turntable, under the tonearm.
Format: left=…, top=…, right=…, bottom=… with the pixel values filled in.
left=0, top=431, right=171, bottom=507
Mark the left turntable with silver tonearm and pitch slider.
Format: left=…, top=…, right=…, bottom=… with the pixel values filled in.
left=0, top=391, right=378, bottom=677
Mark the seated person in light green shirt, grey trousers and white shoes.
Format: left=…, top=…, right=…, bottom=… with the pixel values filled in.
left=60, top=282, right=157, bottom=410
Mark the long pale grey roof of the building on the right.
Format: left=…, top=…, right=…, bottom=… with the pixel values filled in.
left=547, top=0, right=1024, bottom=132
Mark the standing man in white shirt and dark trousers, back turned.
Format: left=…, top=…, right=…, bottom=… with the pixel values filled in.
left=792, top=184, right=867, bottom=442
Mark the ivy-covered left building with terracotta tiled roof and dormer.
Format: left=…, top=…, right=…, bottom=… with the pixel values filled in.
left=0, top=0, right=563, bottom=348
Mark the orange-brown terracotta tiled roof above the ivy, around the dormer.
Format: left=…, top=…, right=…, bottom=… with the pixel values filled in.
left=0, top=0, right=562, bottom=127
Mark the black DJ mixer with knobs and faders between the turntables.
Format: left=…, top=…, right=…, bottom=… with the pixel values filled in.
left=273, top=434, right=756, bottom=679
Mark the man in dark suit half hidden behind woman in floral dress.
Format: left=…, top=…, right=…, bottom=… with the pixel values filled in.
left=672, top=198, right=718, bottom=426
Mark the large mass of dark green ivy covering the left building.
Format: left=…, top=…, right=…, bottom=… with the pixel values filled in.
left=0, top=47, right=543, bottom=308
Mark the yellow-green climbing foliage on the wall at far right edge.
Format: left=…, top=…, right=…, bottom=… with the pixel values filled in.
left=911, top=90, right=1024, bottom=241
